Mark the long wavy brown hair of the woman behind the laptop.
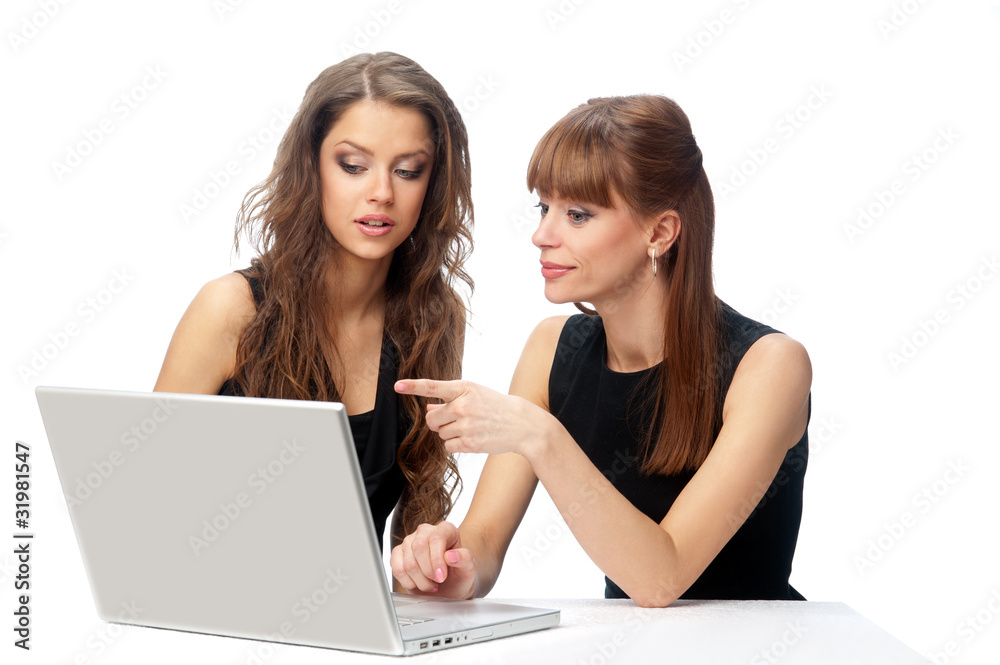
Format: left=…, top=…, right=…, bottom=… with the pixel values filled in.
left=233, top=52, right=473, bottom=533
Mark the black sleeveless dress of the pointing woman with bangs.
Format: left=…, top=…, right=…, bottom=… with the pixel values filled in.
left=549, top=303, right=809, bottom=600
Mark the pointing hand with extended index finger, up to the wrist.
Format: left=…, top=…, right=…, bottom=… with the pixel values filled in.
left=395, top=379, right=561, bottom=457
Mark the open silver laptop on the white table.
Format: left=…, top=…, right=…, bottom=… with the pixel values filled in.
left=35, top=387, right=559, bottom=655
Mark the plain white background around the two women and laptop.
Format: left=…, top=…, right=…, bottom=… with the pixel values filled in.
left=0, top=0, right=1000, bottom=663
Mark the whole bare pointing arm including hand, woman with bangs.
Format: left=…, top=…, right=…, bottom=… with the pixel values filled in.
left=394, top=334, right=812, bottom=607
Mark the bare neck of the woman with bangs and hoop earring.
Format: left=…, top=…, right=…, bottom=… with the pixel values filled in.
left=595, top=279, right=667, bottom=372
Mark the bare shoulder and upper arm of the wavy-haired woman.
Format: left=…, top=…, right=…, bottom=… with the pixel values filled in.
left=153, top=273, right=256, bottom=394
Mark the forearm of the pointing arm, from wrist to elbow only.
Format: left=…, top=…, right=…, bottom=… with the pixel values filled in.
left=525, top=418, right=696, bottom=607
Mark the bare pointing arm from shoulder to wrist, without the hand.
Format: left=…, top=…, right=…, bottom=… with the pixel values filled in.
left=528, top=335, right=812, bottom=607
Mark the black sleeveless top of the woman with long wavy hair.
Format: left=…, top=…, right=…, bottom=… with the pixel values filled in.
left=219, top=270, right=410, bottom=549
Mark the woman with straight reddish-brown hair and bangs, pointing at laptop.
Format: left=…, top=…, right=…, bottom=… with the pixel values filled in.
left=391, top=95, right=812, bottom=607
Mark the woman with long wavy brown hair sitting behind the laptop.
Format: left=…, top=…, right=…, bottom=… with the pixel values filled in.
left=154, top=53, right=473, bottom=544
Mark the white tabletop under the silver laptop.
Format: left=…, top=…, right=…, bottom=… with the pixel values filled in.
left=58, top=599, right=927, bottom=665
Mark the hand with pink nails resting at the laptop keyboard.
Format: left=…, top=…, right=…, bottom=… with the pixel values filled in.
left=389, top=522, right=477, bottom=599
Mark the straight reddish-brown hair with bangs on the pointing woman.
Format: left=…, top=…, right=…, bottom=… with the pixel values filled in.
left=527, top=95, right=722, bottom=474
